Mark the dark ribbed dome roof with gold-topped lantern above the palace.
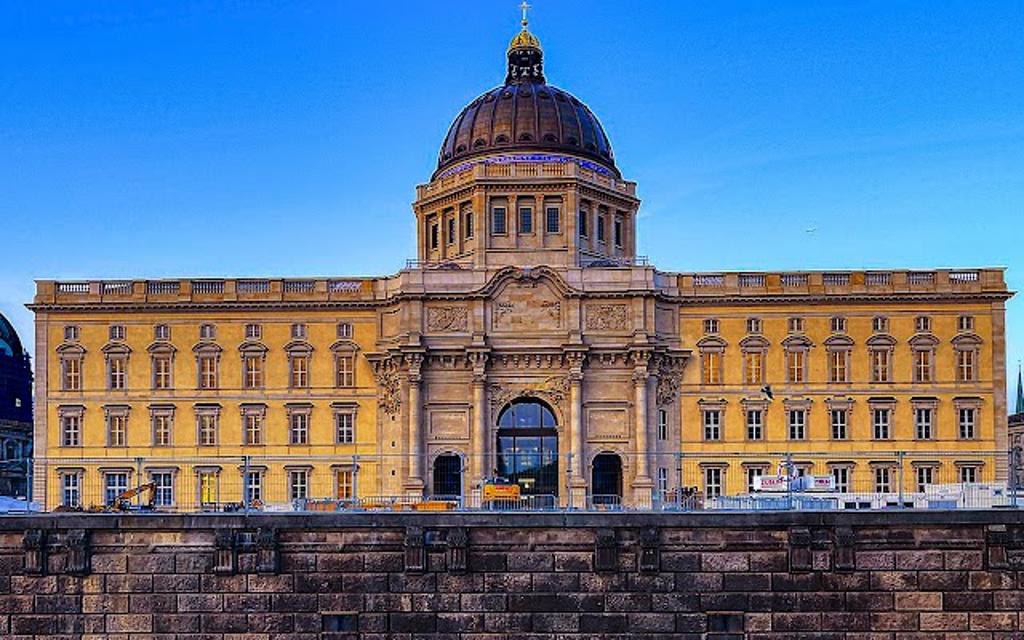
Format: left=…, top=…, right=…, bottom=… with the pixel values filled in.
left=434, top=23, right=620, bottom=177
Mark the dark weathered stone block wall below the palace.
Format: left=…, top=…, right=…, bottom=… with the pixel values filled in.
left=0, top=511, right=1024, bottom=640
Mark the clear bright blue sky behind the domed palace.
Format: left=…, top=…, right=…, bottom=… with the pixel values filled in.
left=0, top=0, right=1024, bottom=399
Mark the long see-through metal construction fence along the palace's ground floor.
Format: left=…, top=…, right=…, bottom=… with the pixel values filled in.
left=28, top=450, right=1024, bottom=512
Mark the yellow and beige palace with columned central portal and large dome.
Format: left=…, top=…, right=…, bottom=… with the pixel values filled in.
left=30, top=19, right=1011, bottom=508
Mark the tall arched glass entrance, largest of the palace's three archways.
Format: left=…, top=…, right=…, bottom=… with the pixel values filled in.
left=495, top=398, right=558, bottom=496
